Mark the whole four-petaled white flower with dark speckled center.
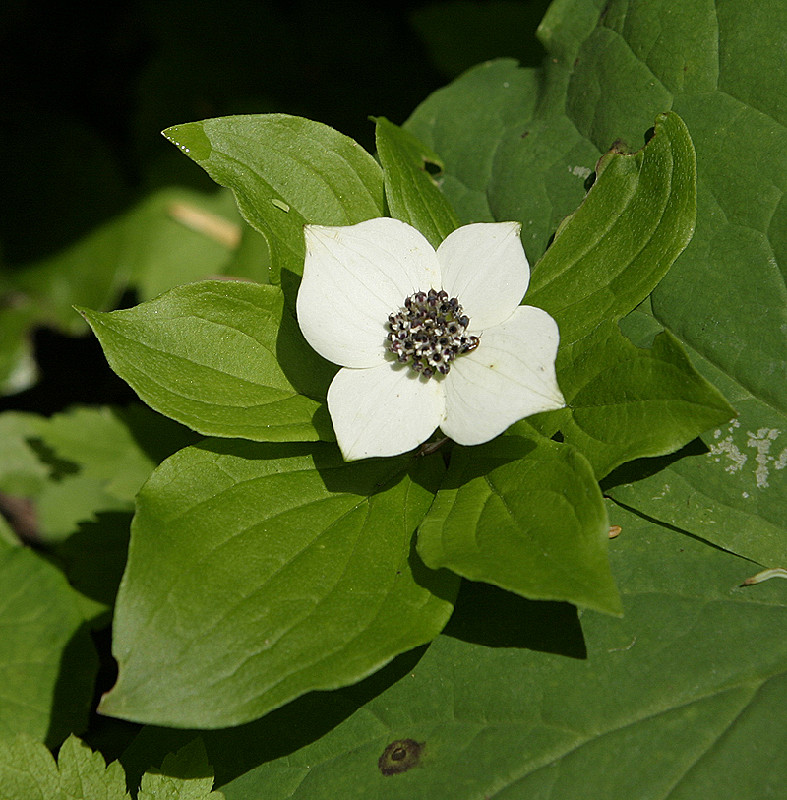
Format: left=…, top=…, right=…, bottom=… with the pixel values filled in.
left=297, top=217, right=565, bottom=461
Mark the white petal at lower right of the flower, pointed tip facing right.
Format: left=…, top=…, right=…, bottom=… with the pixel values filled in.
left=440, top=306, right=565, bottom=445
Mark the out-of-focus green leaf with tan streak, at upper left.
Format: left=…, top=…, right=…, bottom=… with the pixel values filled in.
left=0, top=188, right=249, bottom=356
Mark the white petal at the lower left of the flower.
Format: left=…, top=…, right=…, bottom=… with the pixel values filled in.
left=328, top=362, right=445, bottom=461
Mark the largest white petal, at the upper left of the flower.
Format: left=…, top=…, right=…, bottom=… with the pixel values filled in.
left=296, top=217, right=440, bottom=367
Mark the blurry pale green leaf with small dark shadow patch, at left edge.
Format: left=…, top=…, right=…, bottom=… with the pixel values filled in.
left=0, top=405, right=198, bottom=618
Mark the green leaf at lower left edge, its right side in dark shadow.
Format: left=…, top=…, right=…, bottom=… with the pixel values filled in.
left=0, top=547, right=98, bottom=748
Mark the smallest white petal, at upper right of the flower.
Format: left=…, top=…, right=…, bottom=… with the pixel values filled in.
left=437, top=222, right=530, bottom=333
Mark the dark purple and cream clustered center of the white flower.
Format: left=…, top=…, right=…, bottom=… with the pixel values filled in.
left=387, top=289, right=478, bottom=378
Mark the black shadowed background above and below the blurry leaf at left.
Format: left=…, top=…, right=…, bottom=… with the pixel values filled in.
left=0, top=0, right=548, bottom=413
